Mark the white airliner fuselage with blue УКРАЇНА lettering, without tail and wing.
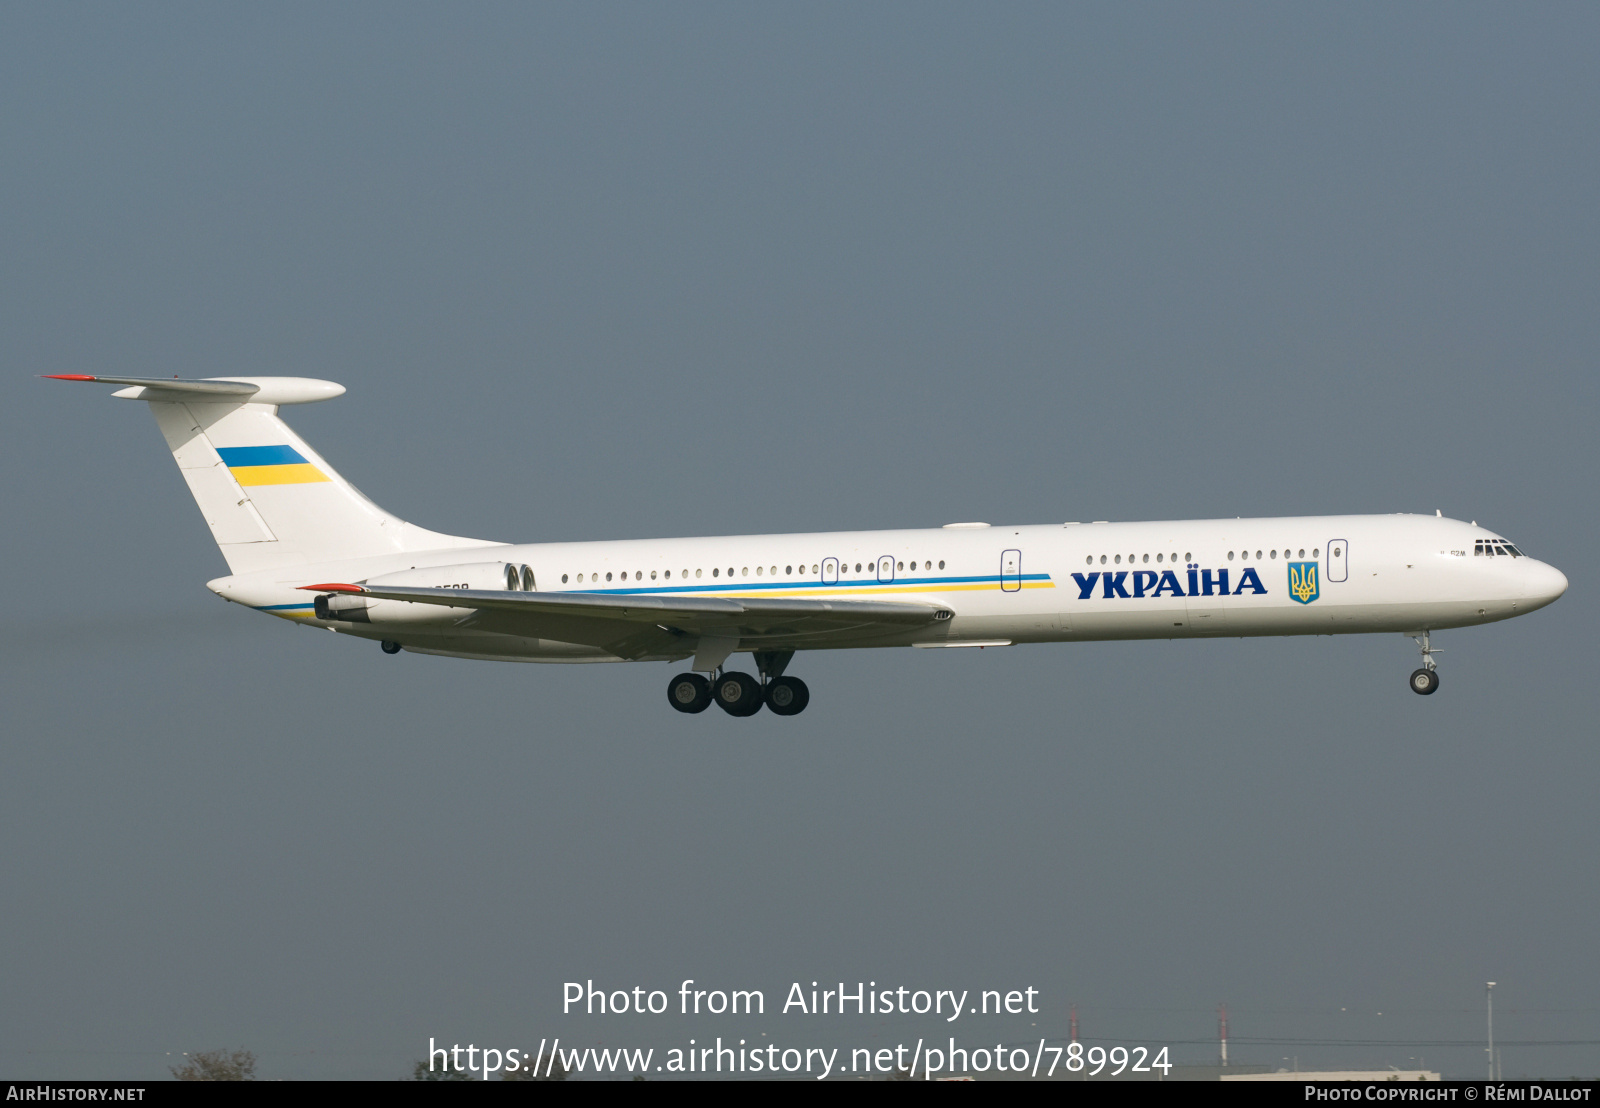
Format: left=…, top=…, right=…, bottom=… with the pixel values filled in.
left=210, top=516, right=1566, bottom=661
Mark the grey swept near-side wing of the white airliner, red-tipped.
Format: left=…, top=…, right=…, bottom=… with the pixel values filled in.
left=302, top=584, right=952, bottom=658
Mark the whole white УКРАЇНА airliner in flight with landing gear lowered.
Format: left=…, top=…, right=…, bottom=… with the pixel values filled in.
left=46, top=373, right=1566, bottom=716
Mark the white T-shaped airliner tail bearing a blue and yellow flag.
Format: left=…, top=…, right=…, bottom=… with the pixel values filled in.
left=58, top=375, right=498, bottom=573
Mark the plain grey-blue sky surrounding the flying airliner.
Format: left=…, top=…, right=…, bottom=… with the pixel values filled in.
left=0, top=5, right=1600, bottom=1078
